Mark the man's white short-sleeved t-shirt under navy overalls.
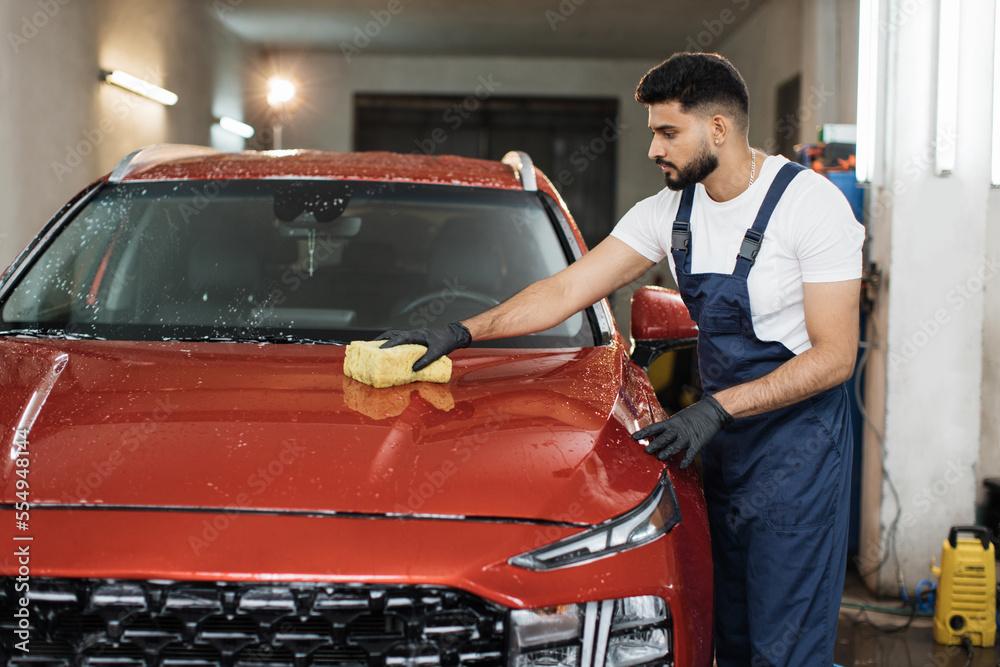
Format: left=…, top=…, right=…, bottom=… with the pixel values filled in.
left=611, top=155, right=865, bottom=354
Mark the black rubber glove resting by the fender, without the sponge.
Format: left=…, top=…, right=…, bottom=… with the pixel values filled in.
left=632, top=394, right=733, bottom=468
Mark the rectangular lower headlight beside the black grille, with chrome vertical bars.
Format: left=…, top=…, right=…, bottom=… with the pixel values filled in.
left=508, top=595, right=672, bottom=667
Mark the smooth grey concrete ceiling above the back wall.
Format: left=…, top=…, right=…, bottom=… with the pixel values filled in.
left=214, top=0, right=766, bottom=59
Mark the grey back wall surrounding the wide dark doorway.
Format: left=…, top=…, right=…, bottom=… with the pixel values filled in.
left=244, top=51, right=669, bottom=227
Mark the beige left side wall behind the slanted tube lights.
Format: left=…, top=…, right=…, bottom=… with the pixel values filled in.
left=0, top=0, right=243, bottom=267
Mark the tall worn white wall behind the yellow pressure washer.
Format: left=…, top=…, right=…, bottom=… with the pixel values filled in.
left=862, top=3, right=1000, bottom=594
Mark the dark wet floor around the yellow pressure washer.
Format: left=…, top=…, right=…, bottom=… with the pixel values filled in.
left=835, top=573, right=1000, bottom=667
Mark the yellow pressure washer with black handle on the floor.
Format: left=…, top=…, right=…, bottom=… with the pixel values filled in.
left=931, top=526, right=997, bottom=646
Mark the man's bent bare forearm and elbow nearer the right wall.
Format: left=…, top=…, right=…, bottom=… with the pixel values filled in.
left=713, top=279, right=861, bottom=417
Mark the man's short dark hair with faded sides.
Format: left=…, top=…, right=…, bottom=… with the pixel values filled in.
left=635, top=51, right=750, bottom=130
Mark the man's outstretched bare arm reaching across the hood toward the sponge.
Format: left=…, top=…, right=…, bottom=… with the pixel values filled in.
left=461, top=236, right=654, bottom=341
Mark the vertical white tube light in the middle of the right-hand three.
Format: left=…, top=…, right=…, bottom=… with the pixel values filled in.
left=934, top=0, right=961, bottom=176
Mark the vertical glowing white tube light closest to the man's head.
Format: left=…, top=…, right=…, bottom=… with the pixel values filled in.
left=854, top=0, right=880, bottom=183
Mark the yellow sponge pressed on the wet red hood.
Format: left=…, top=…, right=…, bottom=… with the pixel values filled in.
left=344, top=340, right=451, bottom=387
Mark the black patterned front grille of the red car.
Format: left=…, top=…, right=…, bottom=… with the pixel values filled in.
left=0, top=577, right=507, bottom=667
